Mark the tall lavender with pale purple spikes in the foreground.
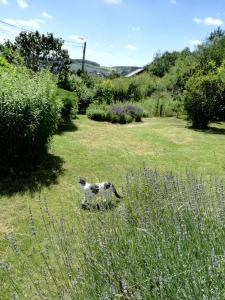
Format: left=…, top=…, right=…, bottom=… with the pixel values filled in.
left=2, top=168, right=225, bottom=299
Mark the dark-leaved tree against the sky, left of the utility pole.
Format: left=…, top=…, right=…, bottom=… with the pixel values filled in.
left=8, top=31, right=71, bottom=77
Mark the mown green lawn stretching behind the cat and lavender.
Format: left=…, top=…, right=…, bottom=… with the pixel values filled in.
left=0, top=116, right=225, bottom=299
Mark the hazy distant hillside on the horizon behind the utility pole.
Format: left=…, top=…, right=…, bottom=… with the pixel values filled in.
left=70, top=59, right=140, bottom=77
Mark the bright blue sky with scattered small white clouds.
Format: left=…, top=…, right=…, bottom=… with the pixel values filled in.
left=0, top=0, right=225, bottom=67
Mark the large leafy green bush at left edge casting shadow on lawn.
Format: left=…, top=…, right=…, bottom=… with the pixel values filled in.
left=0, top=68, right=61, bottom=168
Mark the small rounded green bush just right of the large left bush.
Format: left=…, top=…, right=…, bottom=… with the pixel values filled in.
left=56, top=88, right=78, bottom=122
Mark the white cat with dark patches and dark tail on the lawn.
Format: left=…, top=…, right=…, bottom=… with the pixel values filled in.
left=79, top=178, right=122, bottom=208
